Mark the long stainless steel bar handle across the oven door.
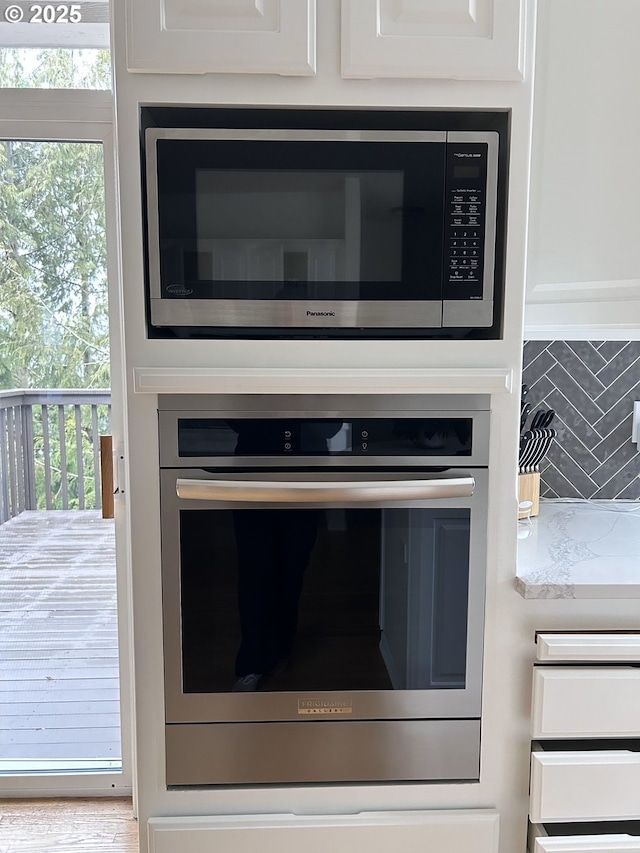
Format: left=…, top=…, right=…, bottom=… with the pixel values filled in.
left=176, top=477, right=475, bottom=504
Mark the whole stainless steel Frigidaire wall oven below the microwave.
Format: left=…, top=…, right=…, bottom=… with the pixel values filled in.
left=159, top=395, right=489, bottom=786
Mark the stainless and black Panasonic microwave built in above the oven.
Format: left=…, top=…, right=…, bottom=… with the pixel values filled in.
left=143, top=108, right=508, bottom=338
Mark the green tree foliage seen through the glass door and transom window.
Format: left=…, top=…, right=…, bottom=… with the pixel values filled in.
left=0, top=50, right=109, bottom=388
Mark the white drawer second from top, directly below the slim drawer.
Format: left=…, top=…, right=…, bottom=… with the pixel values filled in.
left=531, top=666, right=640, bottom=738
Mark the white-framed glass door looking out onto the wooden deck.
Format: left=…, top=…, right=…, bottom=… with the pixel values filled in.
left=0, top=75, right=131, bottom=796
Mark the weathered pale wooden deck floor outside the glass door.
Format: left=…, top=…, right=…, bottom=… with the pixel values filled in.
left=0, top=510, right=121, bottom=772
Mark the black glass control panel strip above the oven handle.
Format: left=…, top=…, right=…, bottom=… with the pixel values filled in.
left=178, top=417, right=473, bottom=459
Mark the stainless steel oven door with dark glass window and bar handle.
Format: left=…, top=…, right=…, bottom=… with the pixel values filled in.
left=161, top=469, right=487, bottom=723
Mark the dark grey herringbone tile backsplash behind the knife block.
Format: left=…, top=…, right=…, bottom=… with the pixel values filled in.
left=522, top=341, right=640, bottom=500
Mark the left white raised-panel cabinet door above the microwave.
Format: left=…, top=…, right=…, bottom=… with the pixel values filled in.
left=127, top=0, right=316, bottom=76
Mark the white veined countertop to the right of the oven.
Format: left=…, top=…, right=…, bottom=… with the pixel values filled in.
left=516, top=499, right=640, bottom=598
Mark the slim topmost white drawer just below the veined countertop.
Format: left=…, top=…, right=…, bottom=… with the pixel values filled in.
left=536, top=631, right=640, bottom=663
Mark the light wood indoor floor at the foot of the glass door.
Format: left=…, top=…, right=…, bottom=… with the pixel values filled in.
left=0, top=798, right=139, bottom=853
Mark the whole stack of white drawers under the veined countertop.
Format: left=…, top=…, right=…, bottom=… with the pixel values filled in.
left=529, top=633, right=640, bottom=853
